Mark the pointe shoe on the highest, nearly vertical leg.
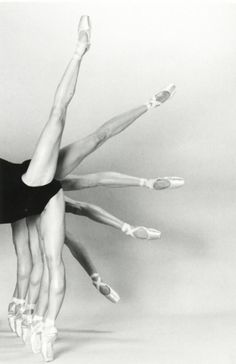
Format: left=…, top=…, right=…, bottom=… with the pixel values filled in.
left=77, top=15, right=91, bottom=55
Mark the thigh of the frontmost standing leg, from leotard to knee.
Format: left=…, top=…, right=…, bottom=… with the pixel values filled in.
left=40, top=189, right=65, bottom=263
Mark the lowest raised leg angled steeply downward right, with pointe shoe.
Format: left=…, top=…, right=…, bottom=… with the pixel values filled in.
left=65, top=232, right=120, bottom=303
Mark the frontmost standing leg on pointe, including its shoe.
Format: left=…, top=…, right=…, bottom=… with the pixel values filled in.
left=40, top=190, right=65, bottom=361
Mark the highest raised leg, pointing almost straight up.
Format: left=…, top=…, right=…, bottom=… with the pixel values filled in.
left=22, top=18, right=89, bottom=186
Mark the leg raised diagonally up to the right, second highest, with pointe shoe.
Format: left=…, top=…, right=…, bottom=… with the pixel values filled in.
left=56, top=85, right=175, bottom=180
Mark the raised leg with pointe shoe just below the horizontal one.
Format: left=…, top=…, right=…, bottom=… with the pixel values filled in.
left=65, top=196, right=161, bottom=240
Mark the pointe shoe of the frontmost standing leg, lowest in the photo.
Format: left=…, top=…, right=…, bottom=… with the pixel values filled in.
left=41, top=326, right=58, bottom=362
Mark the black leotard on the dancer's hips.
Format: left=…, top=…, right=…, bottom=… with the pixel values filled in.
left=0, top=158, right=61, bottom=224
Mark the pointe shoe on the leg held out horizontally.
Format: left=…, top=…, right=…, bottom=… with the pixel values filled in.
left=140, top=177, right=184, bottom=190
